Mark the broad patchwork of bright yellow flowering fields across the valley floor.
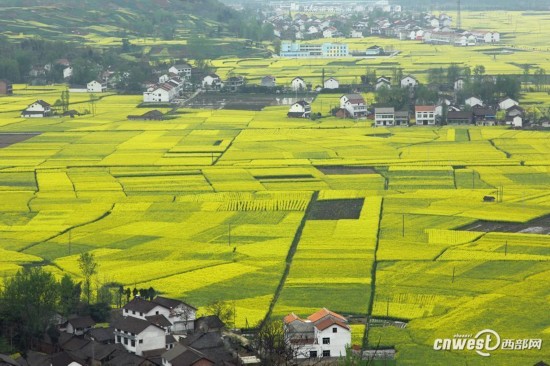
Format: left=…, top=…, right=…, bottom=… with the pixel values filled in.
left=0, top=85, right=550, bottom=365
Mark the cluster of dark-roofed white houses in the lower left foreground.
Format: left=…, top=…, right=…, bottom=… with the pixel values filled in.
left=0, top=296, right=244, bottom=366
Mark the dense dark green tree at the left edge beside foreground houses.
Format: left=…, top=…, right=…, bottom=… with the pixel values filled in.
left=0, top=267, right=59, bottom=350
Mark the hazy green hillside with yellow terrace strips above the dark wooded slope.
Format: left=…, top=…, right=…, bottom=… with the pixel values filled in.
left=0, top=0, right=248, bottom=41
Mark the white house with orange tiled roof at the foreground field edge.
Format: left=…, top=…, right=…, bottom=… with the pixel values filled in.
left=284, top=308, right=351, bottom=358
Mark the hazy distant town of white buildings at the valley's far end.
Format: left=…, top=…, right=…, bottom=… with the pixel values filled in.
left=266, top=3, right=500, bottom=49
